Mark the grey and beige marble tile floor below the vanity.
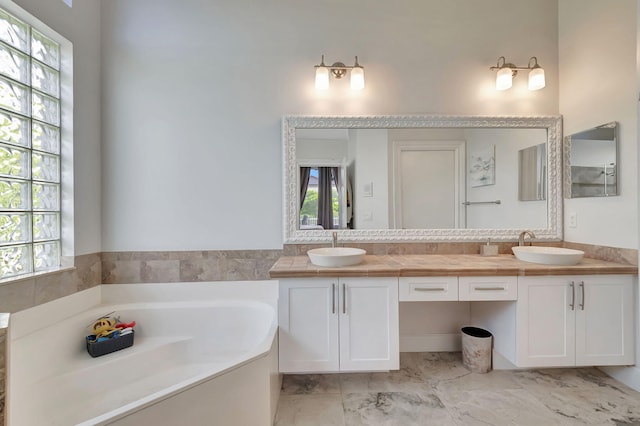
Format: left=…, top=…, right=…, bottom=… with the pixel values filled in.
left=275, top=352, right=640, bottom=426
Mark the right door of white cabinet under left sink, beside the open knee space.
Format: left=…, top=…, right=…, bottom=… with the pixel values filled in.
left=339, top=278, right=400, bottom=371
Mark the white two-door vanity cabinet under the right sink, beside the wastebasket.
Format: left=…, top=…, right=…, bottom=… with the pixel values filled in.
left=515, top=275, right=635, bottom=367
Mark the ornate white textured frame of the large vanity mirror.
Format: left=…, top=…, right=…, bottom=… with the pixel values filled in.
left=282, top=115, right=563, bottom=244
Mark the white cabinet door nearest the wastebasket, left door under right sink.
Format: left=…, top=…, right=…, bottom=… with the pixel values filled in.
left=516, top=277, right=578, bottom=367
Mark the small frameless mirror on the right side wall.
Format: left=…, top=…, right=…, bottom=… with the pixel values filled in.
left=565, top=122, right=619, bottom=198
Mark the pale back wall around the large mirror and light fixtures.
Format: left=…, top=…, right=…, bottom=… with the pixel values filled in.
left=101, top=0, right=558, bottom=251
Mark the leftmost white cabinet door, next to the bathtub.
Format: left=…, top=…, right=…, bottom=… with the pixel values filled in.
left=278, top=278, right=340, bottom=373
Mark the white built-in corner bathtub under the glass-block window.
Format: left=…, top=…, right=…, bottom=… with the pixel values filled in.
left=6, top=281, right=281, bottom=426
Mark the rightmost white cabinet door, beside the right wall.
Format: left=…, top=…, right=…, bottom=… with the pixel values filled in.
left=575, top=275, right=635, bottom=365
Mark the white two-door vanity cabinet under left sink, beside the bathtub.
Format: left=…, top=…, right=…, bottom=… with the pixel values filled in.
left=278, top=277, right=399, bottom=373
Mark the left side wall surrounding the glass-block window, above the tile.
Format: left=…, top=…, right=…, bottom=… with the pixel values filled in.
left=8, top=0, right=102, bottom=255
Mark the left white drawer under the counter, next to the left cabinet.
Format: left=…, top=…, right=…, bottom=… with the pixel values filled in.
left=399, top=277, right=458, bottom=302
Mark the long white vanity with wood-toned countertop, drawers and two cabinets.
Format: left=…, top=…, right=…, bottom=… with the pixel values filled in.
left=270, top=255, right=638, bottom=373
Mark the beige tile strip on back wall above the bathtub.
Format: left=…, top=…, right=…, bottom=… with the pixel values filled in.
left=102, top=250, right=282, bottom=284
